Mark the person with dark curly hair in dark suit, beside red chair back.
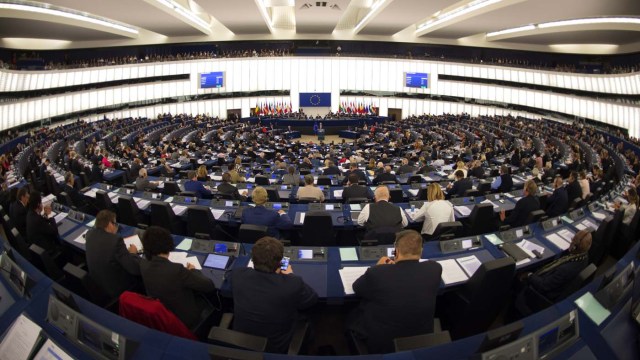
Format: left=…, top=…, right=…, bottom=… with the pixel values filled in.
left=140, top=226, right=216, bottom=328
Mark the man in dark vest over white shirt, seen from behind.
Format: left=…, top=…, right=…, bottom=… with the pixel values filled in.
left=358, top=185, right=409, bottom=232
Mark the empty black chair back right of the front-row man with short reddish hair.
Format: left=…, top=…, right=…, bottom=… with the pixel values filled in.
left=449, top=257, right=516, bottom=339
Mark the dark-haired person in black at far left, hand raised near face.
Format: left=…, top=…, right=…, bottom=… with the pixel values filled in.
left=27, top=191, right=59, bottom=253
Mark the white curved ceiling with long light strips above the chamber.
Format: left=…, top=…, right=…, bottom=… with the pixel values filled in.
left=0, top=0, right=640, bottom=53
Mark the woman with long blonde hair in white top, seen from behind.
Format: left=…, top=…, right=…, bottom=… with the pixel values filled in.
left=411, top=183, right=456, bottom=239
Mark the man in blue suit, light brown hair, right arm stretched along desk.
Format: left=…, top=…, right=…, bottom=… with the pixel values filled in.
left=242, top=186, right=293, bottom=238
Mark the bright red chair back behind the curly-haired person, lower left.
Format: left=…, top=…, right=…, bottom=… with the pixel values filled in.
left=118, top=291, right=197, bottom=340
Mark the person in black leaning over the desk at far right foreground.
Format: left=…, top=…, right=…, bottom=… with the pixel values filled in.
left=521, top=230, right=592, bottom=301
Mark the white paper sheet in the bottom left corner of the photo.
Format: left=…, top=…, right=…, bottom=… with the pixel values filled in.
left=0, top=315, right=42, bottom=360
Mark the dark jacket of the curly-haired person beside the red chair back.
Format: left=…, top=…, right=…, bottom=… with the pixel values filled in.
left=140, top=256, right=216, bottom=328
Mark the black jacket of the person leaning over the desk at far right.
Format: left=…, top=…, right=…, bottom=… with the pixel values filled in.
left=529, top=257, right=589, bottom=300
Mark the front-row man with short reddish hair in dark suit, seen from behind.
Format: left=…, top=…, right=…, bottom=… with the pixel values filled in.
left=347, top=230, right=442, bottom=354
